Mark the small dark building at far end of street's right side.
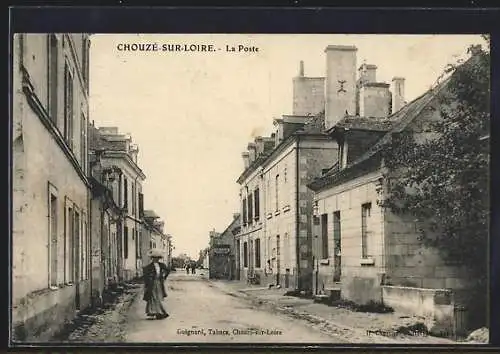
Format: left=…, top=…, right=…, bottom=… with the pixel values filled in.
left=208, top=213, right=241, bottom=280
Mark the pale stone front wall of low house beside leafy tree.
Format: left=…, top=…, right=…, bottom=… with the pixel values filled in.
left=316, top=172, right=385, bottom=303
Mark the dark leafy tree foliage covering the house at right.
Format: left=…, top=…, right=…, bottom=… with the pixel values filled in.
left=381, top=46, right=490, bottom=280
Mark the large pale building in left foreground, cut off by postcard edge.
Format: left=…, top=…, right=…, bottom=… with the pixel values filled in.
left=12, top=34, right=91, bottom=341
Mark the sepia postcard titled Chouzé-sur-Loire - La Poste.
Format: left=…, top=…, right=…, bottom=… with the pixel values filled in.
left=11, top=33, right=490, bottom=346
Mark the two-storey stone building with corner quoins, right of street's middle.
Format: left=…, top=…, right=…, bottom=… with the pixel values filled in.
left=237, top=114, right=337, bottom=290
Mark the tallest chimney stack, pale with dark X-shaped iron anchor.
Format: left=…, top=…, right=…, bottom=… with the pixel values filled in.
left=325, top=45, right=358, bottom=129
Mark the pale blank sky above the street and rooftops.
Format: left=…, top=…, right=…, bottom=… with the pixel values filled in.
left=90, top=34, right=486, bottom=258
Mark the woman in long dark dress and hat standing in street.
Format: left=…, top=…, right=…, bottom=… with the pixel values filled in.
left=143, top=249, right=169, bottom=320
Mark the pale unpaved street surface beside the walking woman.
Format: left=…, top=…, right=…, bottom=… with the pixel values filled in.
left=125, top=272, right=346, bottom=343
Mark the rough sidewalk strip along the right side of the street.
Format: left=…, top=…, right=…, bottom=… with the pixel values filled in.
left=203, top=279, right=465, bottom=345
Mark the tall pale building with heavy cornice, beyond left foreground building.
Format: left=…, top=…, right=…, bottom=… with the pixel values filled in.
left=94, top=127, right=146, bottom=280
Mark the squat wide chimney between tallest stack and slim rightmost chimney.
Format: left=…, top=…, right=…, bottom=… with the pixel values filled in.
left=359, top=82, right=391, bottom=118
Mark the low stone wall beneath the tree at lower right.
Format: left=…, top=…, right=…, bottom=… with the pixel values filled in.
left=382, top=285, right=467, bottom=337
